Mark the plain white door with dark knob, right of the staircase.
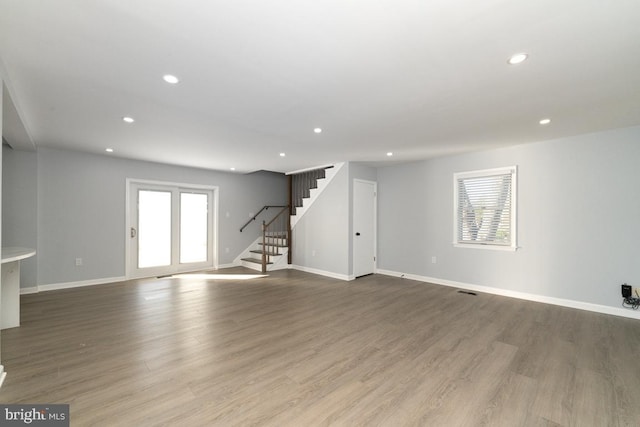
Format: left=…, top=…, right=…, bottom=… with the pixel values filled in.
left=353, top=179, right=377, bottom=277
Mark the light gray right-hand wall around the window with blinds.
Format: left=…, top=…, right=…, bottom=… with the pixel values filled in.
left=378, top=127, right=640, bottom=307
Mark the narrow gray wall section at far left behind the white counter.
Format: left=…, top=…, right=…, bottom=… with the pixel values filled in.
left=2, top=147, right=38, bottom=288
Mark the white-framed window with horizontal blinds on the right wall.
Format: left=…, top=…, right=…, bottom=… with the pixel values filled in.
left=454, top=166, right=517, bottom=249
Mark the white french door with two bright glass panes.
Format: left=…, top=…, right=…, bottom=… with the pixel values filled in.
left=127, top=181, right=216, bottom=278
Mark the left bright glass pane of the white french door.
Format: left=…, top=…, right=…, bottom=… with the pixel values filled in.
left=138, top=190, right=171, bottom=268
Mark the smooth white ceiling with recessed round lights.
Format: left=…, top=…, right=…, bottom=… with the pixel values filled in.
left=0, top=0, right=640, bottom=172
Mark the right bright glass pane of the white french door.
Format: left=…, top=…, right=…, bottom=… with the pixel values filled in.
left=180, top=193, right=209, bottom=264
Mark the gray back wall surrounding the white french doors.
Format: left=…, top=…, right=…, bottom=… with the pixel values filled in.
left=4, top=148, right=287, bottom=286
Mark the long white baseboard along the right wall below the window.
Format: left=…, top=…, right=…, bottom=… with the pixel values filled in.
left=376, top=270, right=640, bottom=319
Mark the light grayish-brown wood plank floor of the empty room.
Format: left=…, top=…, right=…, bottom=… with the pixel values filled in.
left=0, top=268, right=640, bottom=427
